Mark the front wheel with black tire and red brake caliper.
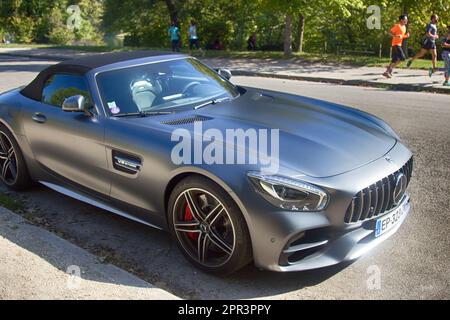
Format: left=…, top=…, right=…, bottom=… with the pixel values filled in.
left=167, top=176, right=252, bottom=276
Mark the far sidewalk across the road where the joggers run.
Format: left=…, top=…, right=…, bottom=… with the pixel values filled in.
left=0, top=48, right=450, bottom=93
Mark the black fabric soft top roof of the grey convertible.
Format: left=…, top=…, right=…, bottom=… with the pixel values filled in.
left=21, top=51, right=173, bottom=101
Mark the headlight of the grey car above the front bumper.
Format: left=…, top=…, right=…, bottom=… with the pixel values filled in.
left=247, top=172, right=328, bottom=211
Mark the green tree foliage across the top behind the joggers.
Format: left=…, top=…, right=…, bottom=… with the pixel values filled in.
left=0, top=0, right=450, bottom=54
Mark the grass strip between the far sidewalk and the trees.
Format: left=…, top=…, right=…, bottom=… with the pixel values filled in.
left=0, top=44, right=444, bottom=69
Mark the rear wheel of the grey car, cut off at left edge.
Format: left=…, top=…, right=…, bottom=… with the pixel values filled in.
left=0, top=124, right=33, bottom=191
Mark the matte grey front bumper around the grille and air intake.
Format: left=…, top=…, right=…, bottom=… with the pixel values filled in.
left=239, top=143, right=412, bottom=272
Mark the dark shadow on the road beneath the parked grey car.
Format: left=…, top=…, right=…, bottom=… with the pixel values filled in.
left=0, top=186, right=348, bottom=299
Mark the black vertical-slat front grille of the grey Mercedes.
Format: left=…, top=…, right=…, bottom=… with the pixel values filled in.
left=345, top=157, right=413, bottom=223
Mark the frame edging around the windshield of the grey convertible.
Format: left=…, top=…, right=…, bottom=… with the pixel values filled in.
left=93, top=57, right=241, bottom=118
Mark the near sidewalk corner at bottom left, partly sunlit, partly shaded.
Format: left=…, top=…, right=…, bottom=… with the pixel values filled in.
left=0, top=207, right=177, bottom=300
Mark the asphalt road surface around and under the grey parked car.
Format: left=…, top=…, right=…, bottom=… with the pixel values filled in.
left=0, top=57, right=450, bottom=299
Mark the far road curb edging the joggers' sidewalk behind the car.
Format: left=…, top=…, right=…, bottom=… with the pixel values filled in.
left=0, top=52, right=450, bottom=94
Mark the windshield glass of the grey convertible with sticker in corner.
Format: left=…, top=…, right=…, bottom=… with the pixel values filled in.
left=96, top=58, right=239, bottom=116
